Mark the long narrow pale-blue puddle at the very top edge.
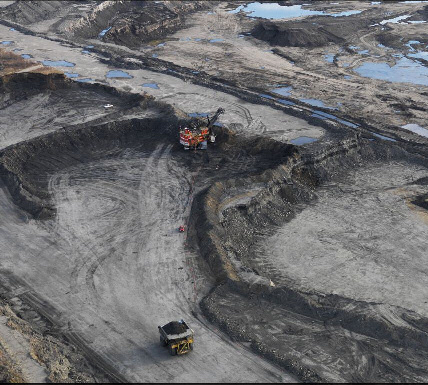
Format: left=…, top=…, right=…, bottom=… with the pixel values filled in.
left=229, top=2, right=362, bottom=19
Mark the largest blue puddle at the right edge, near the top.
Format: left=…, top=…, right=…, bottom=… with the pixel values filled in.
left=355, top=57, right=428, bottom=86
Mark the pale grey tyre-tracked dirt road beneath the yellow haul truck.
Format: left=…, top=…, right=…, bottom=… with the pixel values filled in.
left=0, top=144, right=294, bottom=382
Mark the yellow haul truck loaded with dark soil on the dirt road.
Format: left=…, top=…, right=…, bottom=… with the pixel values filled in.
left=158, top=320, right=193, bottom=356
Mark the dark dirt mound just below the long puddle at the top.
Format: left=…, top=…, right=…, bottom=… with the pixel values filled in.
left=251, top=21, right=344, bottom=47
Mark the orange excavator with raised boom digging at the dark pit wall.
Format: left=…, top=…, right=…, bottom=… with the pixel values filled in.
left=180, top=108, right=224, bottom=150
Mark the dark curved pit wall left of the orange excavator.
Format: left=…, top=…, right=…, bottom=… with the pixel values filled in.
left=0, top=73, right=182, bottom=219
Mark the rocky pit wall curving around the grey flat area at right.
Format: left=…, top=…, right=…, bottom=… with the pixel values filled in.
left=192, top=135, right=428, bottom=382
